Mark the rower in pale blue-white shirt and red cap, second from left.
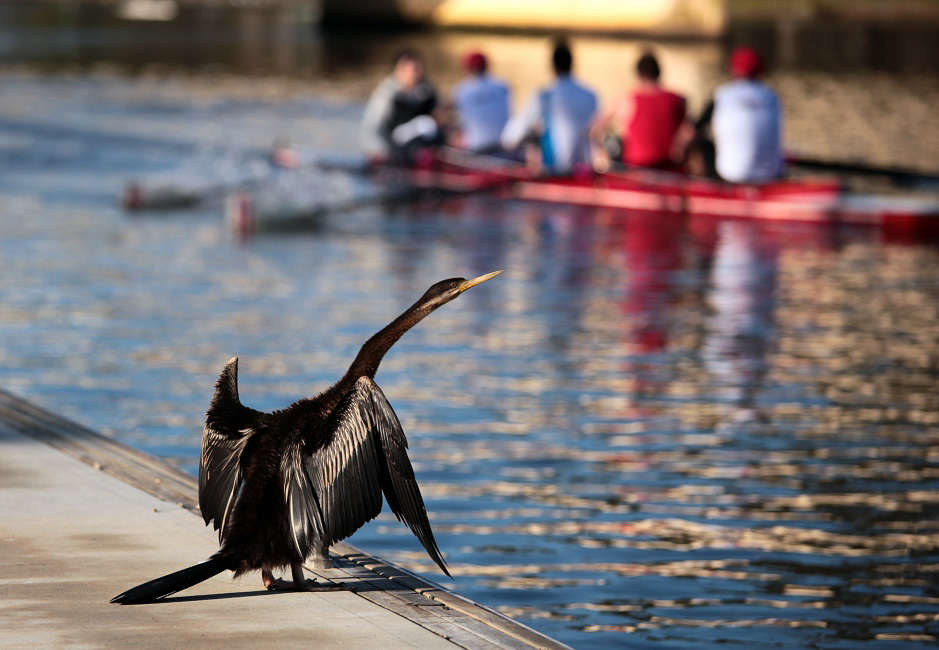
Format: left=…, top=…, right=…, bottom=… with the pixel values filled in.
left=453, top=52, right=510, bottom=153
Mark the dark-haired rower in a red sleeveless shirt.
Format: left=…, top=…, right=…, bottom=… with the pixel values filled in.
left=593, top=53, right=687, bottom=169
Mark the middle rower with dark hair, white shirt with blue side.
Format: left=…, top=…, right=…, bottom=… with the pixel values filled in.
left=502, top=41, right=597, bottom=172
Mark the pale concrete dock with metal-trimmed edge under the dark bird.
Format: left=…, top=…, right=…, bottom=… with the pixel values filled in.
left=0, top=391, right=567, bottom=650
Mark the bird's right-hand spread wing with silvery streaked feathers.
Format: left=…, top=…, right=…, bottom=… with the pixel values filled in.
left=285, top=377, right=450, bottom=576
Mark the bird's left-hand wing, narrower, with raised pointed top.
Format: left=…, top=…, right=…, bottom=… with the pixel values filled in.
left=199, top=357, right=261, bottom=540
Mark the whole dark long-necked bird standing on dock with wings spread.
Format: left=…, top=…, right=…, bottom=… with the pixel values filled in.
left=112, top=271, right=500, bottom=604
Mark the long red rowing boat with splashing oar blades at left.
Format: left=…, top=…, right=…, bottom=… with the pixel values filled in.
left=128, top=148, right=939, bottom=239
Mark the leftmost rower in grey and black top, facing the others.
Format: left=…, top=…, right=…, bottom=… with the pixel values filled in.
left=362, top=49, right=440, bottom=162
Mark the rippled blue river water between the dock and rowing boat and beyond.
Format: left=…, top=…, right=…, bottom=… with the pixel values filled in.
left=0, top=75, right=939, bottom=648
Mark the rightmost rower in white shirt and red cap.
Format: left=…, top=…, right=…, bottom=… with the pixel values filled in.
left=711, top=47, right=785, bottom=183
